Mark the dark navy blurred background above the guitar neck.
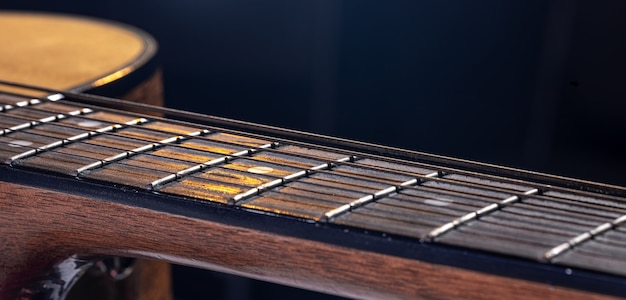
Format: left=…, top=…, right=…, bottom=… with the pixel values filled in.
left=0, top=0, right=626, bottom=298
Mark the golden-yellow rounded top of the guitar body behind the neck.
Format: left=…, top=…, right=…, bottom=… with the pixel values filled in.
left=0, top=12, right=156, bottom=92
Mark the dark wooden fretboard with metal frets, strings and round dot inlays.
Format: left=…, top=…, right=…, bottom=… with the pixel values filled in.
left=0, top=91, right=626, bottom=276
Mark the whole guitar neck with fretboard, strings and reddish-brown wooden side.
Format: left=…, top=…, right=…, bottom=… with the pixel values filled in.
left=0, top=10, right=626, bottom=299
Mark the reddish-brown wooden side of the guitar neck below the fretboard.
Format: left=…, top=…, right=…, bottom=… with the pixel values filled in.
left=0, top=182, right=610, bottom=299
